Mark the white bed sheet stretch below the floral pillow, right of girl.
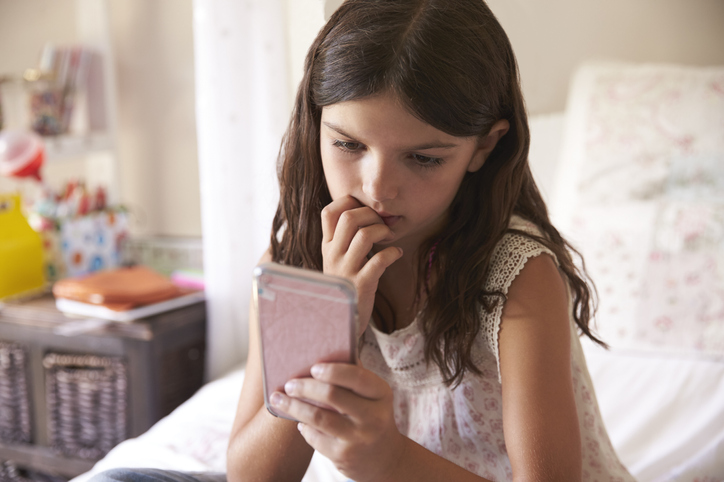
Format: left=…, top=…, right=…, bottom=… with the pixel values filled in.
left=584, top=342, right=724, bottom=482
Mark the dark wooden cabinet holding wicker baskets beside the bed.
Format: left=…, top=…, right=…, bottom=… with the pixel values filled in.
left=0, top=295, right=206, bottom=478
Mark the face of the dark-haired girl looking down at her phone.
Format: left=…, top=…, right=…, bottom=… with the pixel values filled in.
left=320, top=94, right=494, bottom=253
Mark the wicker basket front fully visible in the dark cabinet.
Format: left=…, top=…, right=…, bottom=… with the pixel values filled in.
left=43, top=353, right=128, bottom=459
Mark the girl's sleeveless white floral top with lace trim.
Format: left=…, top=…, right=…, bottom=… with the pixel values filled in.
left=360, top=217, right=634, bottom=482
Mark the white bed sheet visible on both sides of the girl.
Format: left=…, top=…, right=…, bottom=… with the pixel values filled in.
left=73, top=343, right=724, bottom=482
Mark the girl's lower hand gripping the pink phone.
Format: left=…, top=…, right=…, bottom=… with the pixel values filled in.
left=271, top=363, right=408, bottom=482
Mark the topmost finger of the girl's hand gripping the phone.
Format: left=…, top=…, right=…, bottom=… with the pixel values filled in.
left=312, top=363, right=391, bottom=402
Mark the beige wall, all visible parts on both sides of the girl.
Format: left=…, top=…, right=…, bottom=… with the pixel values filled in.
left=0, top=0, right=724, bottom=236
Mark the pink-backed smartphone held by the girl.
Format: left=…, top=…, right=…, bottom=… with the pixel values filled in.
left=253, top=263, right=357, bottom=420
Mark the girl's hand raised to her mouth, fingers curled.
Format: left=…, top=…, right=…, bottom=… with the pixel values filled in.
left=322, top=196, right=402, bottom=337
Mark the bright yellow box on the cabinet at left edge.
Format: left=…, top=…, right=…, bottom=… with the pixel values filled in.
left=0, top=194, right=45, bottom=298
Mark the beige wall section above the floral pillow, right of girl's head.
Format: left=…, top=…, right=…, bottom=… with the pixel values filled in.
left=488, top=0, right=724, bottom=114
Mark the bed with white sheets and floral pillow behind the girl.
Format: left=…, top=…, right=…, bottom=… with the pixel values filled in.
left=69, top=63, right=724, bottom=482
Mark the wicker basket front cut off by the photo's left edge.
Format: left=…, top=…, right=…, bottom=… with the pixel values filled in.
left=0, top=341, right=31, bottom=443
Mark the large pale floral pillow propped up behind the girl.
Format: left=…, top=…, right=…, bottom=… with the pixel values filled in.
left=552, top=64, right=724, bottom=358
